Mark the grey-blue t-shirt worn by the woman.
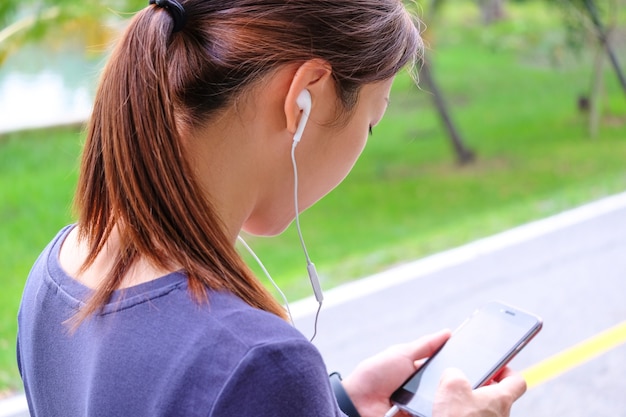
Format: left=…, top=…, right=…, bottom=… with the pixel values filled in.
left=17, top=226, right=344, bottom=417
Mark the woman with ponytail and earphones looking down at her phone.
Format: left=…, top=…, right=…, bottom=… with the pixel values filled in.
left=18, top=0, right=525, bottom=417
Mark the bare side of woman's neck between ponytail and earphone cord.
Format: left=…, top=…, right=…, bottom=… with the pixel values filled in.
left=185, top=75, right=293, bottom=240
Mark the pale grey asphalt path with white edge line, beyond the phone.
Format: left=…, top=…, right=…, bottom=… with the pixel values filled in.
left=0, top=193, right=626, bottom=417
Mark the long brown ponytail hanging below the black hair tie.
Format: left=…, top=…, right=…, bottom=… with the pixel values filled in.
left=75, top=7, right=285, bottom=323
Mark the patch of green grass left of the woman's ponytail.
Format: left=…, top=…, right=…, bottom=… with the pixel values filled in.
left=0, top=129, right=81, bottom=391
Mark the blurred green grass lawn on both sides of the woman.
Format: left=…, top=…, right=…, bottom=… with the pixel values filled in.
left=0, top=2, right=626, bottom=390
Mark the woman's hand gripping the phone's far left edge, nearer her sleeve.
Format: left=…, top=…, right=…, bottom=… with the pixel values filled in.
left=343, top=330, right=450, bottom=417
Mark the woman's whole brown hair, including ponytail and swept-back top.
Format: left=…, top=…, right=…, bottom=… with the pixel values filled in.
left=75, top=0, right=421, bottom=322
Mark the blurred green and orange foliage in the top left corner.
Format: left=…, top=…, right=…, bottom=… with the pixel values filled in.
left=0, top=0, right=147, bottom=65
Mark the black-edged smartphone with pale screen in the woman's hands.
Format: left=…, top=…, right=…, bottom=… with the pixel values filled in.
left=391, top=301, right=543, bottom=417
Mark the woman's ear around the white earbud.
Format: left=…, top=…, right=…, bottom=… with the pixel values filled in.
left=285, top=59, right=334, bottom=135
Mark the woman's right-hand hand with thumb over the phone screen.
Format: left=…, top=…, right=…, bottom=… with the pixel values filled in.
left=433, top=368, right=526, bottom=417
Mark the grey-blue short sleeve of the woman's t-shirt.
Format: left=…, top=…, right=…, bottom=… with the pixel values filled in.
left=209, top=340, right=345, bottom=417
